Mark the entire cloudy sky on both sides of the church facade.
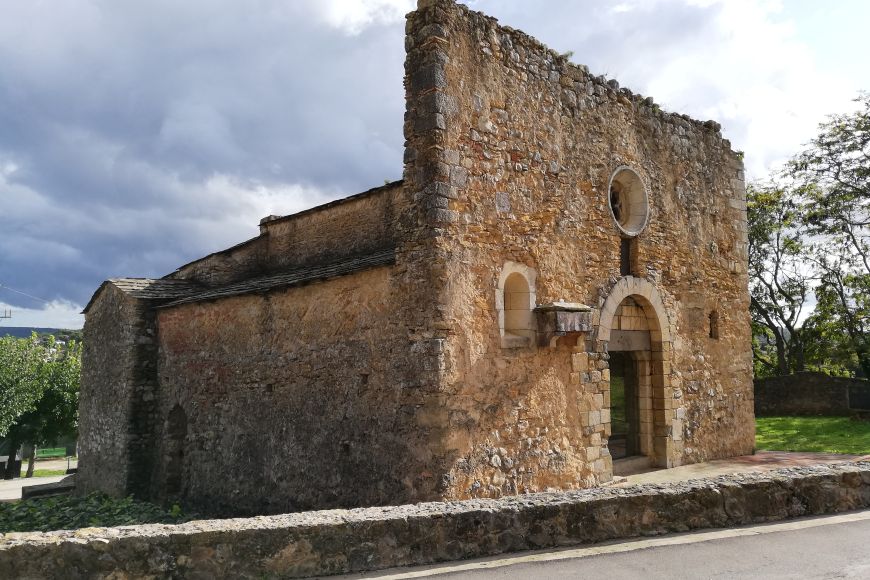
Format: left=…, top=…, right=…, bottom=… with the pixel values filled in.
left=0, top=0, right=870, bottom=328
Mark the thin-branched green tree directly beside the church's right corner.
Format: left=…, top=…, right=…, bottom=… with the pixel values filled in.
left=747, top=185, right=812, bottom=376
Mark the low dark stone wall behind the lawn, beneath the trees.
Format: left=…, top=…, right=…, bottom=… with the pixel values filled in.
left=755, top=372, right=870, bottom=417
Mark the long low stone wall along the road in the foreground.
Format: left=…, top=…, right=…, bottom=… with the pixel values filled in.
left=0, top=462, right=870, bottom=579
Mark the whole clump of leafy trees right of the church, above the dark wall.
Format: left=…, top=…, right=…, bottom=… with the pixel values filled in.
left=747, top=93, right=870, bottom=377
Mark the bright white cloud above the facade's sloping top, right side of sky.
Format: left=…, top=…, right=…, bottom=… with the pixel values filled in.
left=469, top=0, right=870, bottom=178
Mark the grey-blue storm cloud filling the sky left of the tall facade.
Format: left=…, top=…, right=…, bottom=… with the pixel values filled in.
left=0, top=1, right=404, bottom=307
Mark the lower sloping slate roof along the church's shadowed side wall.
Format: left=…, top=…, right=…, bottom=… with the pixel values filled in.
left=160, top=248, right=396, bottom=308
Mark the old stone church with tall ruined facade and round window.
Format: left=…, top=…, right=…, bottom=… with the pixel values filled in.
left=77, top=0, right=754, bottom=514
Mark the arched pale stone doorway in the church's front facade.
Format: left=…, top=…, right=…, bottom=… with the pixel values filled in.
left=596, top=276, right=682, bottom=467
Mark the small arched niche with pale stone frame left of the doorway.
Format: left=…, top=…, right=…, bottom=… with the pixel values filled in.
left=495, top=262, right=537, bottom=348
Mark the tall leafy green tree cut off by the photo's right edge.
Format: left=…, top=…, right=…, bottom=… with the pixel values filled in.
left=789, top=93, right=870, bottom=377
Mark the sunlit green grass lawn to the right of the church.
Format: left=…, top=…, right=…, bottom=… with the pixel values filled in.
left=755, top=417, right=870, bottom=455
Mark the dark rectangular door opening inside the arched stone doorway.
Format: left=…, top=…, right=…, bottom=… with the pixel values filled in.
left=608, top=352, right=640, bottom=459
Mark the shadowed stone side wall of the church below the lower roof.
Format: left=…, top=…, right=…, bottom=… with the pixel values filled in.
left=155, top=267, right=438, bottom=514
